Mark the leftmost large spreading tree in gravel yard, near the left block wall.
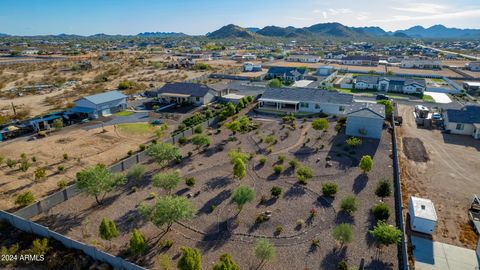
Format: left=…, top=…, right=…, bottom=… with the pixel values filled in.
left=75, top=164, right=126, bottom=204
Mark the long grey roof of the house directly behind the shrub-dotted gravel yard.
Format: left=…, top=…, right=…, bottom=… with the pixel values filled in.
left=261, top=88, right=353, bottom=104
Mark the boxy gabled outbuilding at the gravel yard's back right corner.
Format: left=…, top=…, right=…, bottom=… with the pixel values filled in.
left=345, top=102, right=385, bottom=139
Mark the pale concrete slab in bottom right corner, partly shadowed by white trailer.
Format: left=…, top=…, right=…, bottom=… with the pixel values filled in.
left=411, top=236, right=478, bottom=270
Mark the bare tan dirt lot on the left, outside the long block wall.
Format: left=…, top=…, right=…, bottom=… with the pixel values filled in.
left=0, top=119, right=173, bottom=210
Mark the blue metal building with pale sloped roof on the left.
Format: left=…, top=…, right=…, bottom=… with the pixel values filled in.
left=70, top=91, right=127, bottom=119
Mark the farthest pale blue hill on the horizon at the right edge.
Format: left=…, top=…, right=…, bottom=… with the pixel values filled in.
left=395, top=24, right=480, bottom=38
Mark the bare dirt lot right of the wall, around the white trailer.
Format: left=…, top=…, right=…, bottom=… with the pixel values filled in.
left=398, top=105, right=480, bottom=249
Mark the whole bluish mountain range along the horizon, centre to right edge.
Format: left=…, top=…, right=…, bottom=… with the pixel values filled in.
left=207, top=23, right=480, bottom=39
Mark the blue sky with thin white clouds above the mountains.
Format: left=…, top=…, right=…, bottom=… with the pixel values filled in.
left=0, top=0, right=480, bottom=35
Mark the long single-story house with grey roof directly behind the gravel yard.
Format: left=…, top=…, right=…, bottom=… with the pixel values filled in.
left=258, top=88, right=353, bottom=115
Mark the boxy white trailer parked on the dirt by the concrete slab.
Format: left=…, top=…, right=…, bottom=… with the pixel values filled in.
left=408, top=196, right=437, bottom=235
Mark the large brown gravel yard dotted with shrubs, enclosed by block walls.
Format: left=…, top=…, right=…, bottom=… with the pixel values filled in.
left=34, top=116, right=398, bottom=270
